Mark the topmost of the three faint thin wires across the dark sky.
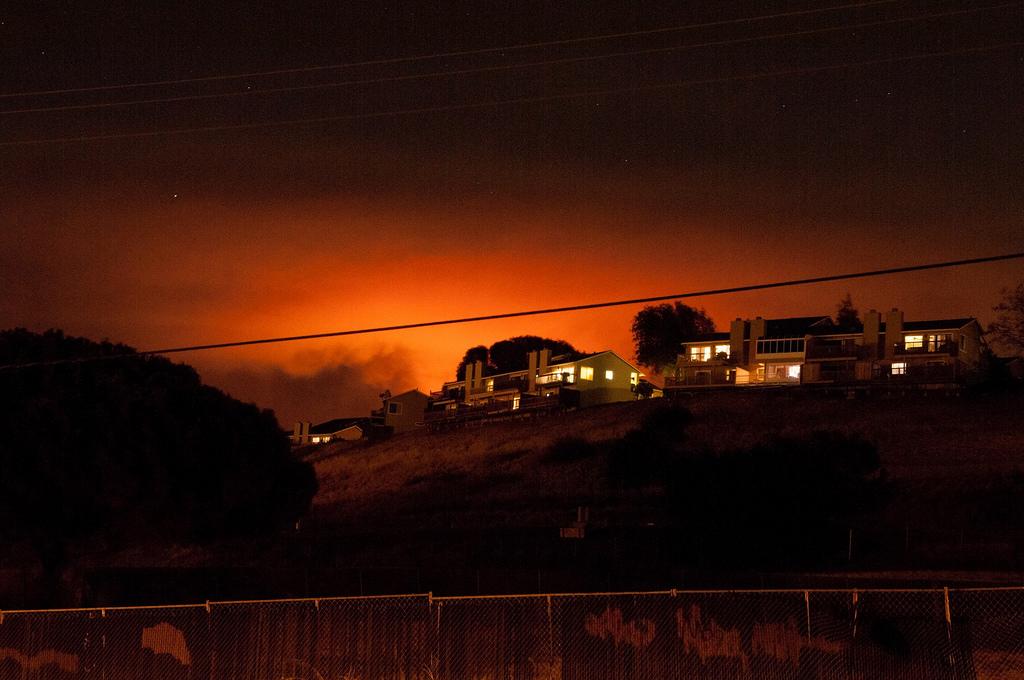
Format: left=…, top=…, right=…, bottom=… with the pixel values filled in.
left=0, top=0, right=900, bottom=98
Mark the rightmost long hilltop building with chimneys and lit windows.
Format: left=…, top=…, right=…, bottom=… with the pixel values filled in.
left=666, top=308, right=983, bottom=390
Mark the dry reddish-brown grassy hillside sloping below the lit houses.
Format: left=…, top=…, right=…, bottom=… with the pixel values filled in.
left=313, top=390, right=1024, bottom=525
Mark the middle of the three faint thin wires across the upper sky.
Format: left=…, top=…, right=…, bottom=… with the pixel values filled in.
left=0, top=0, right=1024, bottom=116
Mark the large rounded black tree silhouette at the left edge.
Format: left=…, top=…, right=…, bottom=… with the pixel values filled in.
left=0, top=329, right=316, bottom=606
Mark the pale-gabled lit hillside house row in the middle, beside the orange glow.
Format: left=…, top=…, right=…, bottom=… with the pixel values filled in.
left=426, top=349, right=643, bottom=423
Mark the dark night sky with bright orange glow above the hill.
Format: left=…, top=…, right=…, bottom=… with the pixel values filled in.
left=0, top=0, right=1024, bottom=426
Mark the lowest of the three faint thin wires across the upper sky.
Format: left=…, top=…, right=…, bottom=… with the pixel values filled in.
left=0, top=41, right=1024, bottom=147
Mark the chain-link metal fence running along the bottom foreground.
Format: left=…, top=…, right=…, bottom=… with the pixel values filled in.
left=0, top=588, right=1024, bottom=680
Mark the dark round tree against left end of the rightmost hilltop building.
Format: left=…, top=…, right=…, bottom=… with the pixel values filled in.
left=633, top=302, right=715, bottom=373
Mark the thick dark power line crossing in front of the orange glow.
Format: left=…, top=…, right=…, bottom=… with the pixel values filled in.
left=0, top=252, right=1024, bottom=371
